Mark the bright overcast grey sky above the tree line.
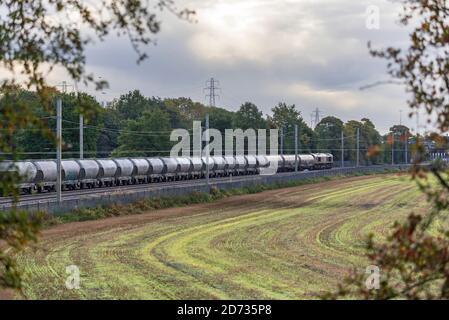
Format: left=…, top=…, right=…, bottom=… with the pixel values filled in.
left=54, top=0, right=422, bottom=133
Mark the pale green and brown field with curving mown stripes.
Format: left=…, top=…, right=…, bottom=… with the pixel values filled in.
left=14, top=175, right=427, bottom=299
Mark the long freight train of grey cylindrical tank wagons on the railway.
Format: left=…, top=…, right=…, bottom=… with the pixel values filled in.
left=0, top=153, right=333, bottom=194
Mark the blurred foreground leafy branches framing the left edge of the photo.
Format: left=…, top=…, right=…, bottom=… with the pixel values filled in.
left=0, top=0, right=193, bottom=288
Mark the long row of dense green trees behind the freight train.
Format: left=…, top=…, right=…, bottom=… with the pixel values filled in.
left=4, top=89, right=410, bottom=164
